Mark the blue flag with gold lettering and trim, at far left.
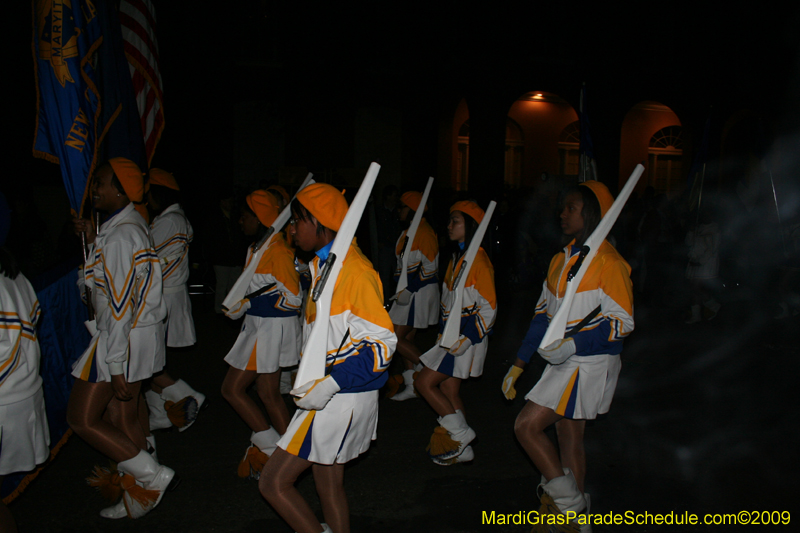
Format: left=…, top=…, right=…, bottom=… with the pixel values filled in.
left=33, top=0, right=103, bottom=213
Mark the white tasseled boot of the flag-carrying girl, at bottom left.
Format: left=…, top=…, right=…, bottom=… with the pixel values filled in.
left=100, top=450, right=175, bottom=518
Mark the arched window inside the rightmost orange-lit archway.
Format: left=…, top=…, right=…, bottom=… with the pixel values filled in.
left=647, top=126, right=684, bottom=195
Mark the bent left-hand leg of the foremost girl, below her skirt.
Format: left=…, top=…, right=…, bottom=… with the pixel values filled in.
left=258, top=448, right=324, bottom=533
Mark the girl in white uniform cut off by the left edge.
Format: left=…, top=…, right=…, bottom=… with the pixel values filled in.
left=0, top=193, right=50, bottom=532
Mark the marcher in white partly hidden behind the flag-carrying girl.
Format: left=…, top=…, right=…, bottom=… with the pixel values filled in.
left=145, top=168, right=206, bottom=431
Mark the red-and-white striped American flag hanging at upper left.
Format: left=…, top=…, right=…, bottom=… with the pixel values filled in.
left=119, top=0, right=164, bottom=163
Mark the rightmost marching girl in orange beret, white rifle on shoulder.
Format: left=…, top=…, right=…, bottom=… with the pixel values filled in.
left=510, top=181, right=633, bottom=531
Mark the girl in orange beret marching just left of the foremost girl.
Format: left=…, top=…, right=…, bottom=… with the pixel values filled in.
left=222, top=190, right=301, bottom=479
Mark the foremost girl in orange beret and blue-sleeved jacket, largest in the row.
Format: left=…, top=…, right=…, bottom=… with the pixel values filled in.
left=259, top=183, right=397, bottom=533
